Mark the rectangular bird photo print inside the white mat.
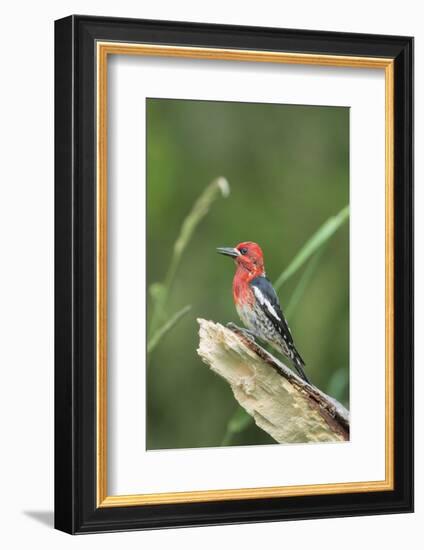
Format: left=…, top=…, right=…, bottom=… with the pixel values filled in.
left=146, top=98, right=349, bottom=450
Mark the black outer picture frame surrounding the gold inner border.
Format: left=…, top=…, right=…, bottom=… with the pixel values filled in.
left=55, top=15, right=413, bottom=534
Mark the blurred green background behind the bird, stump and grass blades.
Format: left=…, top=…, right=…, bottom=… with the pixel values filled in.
left=146, top=99, right=349, bottom=449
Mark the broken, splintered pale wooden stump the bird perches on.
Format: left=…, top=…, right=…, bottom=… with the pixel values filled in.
left=197, top=319, right=349, bottom=443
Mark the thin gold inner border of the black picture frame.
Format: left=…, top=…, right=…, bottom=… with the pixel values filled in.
left=96, top=41, right=394, bottom=508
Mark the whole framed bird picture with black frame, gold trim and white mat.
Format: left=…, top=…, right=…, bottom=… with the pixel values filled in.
left=55, top=16, right=413, bottom=534
